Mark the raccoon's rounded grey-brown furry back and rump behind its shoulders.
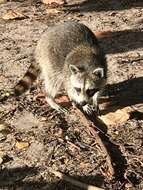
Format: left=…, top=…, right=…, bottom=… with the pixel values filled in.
left=35, top=22, right=98, bottom=69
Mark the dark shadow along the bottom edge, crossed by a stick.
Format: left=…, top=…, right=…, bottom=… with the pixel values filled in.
left=0, top=167, right=105, bottom=190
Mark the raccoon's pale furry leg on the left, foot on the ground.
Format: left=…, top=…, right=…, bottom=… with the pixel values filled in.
left=45, top=74, right=68, bottom=113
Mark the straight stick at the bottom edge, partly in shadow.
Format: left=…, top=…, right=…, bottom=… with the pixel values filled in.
left=50, top=169, right=104, bottom=190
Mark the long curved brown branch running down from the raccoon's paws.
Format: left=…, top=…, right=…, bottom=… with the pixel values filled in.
left=75, top=108, right=115, bottom=179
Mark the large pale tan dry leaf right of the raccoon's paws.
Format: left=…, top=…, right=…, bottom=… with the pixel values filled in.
left=99, top=107, right=133, bottom=125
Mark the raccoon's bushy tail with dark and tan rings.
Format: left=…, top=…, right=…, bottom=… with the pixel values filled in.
left=14, top=64, right=39, bottom=96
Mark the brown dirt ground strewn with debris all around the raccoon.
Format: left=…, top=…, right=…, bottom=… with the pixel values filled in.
left=0, top=0, right=143, bottom=190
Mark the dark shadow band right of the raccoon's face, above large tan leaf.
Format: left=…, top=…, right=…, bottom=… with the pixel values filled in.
left=101, top=77, right=143, bottom=116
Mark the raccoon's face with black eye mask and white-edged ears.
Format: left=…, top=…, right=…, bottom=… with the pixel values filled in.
left=69, top=65, right=104, bottom=106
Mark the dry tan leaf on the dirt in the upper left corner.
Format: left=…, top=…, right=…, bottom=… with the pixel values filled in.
left=2, top=10, right=27, bottom=20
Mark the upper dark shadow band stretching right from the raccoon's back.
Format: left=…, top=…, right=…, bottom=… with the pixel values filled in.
left=98, top=29, right=143, bottom=54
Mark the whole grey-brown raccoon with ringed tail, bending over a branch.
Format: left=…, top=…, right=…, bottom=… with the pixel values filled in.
left=15, top=21, right=107, bottom=114
